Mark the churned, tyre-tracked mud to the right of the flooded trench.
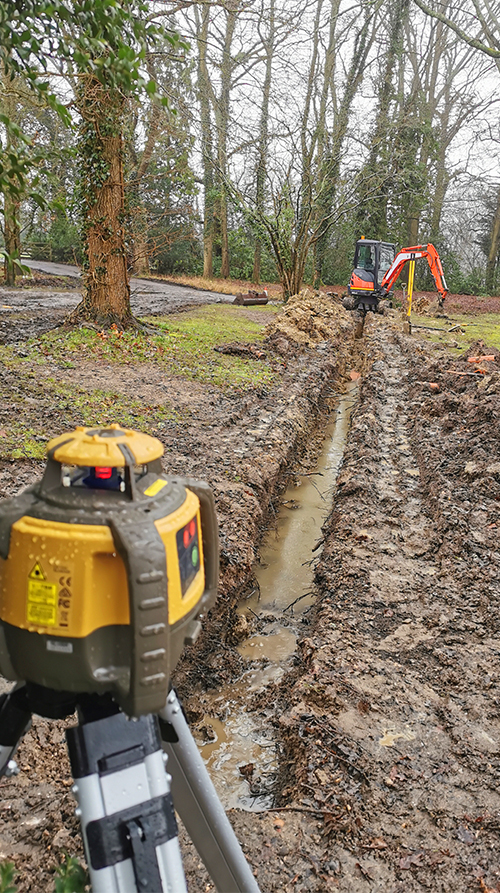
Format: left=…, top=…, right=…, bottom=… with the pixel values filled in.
left=273, top=322, right=500, bottom=893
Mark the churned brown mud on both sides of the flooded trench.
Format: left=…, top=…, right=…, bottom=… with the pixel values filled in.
left=0, top=284, right=500, bottom=893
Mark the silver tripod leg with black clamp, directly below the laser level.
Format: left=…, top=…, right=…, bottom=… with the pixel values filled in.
left=66, top=700, right=186, bottom=893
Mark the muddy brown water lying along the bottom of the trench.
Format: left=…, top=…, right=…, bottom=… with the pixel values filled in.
left=193, top=382, right=359, bottom=811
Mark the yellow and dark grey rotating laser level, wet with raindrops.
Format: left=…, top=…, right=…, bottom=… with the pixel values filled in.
left=0, top=425, right=218, bottom=716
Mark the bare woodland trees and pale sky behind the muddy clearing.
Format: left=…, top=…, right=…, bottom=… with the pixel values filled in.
left=0, top=0, right=500, bottom=297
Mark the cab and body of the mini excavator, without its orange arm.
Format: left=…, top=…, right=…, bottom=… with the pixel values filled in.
left=347, top=238, right=396, bottom=311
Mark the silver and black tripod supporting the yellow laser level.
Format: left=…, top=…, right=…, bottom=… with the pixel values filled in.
left=0, top=683, right=259, bottom=893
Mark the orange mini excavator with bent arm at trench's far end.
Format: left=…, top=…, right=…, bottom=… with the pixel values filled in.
left=346, top=238, right=448, bottom=314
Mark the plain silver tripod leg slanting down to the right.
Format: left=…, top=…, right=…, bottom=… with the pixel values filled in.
left=160, top=689, right=259, bottom=893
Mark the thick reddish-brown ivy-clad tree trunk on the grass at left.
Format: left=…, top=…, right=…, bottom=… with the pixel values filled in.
left=69, top=75, right=133, bottom=327
